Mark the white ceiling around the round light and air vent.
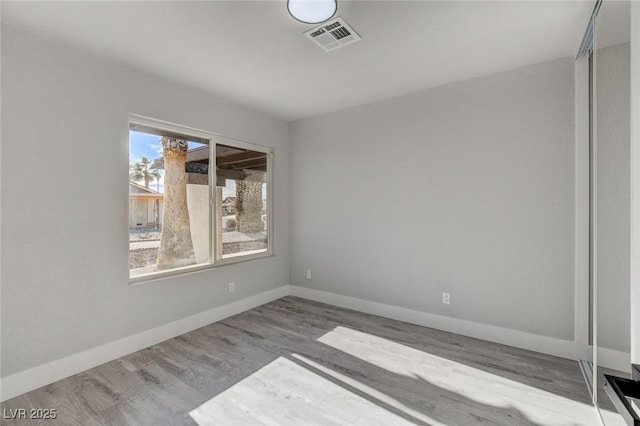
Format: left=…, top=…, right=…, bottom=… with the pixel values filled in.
left=2, top=0, right=593, bottom=120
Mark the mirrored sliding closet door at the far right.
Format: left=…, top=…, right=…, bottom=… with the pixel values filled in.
left=591, top=1, right=630, bottom=423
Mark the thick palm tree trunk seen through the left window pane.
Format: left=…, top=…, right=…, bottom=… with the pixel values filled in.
left=156, top=136, right=196, bottom=269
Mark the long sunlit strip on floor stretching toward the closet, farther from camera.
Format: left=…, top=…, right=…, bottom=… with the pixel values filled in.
left=317, top=326, right=599, bottom=425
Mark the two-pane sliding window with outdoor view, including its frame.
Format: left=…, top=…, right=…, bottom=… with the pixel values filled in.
left=128, top=116, right=272, bottom=282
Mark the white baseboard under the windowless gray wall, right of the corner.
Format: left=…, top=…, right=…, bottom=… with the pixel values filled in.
left=291, top=286, right=591, bottom=360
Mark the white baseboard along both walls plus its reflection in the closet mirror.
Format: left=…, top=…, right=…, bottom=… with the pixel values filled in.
left=0, top=285, right=630, bottom=401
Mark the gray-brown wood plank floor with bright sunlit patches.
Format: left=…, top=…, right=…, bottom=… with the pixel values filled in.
left=2, top=297, right=598, bottom=425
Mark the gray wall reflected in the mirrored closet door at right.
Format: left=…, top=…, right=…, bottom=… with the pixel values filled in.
left=596, top=43, right=631, bottom=352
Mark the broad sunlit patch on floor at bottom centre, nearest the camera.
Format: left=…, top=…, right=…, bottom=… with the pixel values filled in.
left=189, top=357, right=424, bottom=426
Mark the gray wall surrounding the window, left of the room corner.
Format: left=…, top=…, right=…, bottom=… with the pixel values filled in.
left=1, top=24, right=289, bottom=376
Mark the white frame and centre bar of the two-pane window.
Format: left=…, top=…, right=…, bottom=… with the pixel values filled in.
left=125, top=114, right=275, bottom=284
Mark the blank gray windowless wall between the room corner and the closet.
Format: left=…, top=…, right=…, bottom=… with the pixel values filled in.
left=289, top=58, right=574, bottom=340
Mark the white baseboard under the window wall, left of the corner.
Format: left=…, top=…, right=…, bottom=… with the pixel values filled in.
left=0, top=285, right=290, bottom=401
